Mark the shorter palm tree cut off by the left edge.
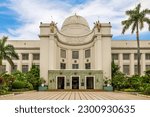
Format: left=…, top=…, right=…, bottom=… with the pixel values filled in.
left=0, top=36, right=19, bottom=72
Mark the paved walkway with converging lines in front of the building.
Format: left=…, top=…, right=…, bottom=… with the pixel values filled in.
left=0, top=91, right=150, bottom=100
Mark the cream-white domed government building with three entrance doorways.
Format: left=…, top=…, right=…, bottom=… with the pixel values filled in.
left=3, top=15, right=150, bottom=89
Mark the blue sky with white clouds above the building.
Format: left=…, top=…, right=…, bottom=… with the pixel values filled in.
left=0, top=0, right=150, bottom=40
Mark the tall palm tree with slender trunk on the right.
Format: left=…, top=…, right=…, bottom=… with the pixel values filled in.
left=122, top=4, right=150, bottom=75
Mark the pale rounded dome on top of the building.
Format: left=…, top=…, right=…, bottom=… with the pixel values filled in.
left=61, top=15, right=90, bottom=36
